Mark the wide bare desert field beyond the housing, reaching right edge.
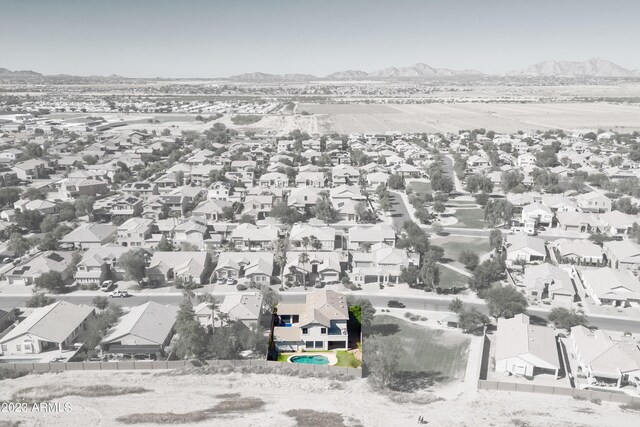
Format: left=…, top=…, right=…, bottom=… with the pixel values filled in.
left=298, top=102, right=640, bottom=133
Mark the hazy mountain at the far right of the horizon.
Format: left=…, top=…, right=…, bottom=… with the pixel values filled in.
left=507, top=59, right=640, bottom=78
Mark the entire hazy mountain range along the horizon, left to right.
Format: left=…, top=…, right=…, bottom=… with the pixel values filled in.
left=0, top=59, right=640, bottom=82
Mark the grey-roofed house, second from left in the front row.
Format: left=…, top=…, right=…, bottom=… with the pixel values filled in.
left=100, top=301, right=179, bottom=359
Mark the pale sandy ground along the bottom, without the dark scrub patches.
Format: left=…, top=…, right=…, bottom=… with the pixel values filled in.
left=0, top=372, right=639, bottom=426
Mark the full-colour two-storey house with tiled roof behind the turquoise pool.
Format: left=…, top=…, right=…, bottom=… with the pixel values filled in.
left=273, top=290, right=349, bottom=352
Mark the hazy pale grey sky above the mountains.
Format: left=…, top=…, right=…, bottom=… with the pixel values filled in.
left=0, top=0, right=640, bottom=77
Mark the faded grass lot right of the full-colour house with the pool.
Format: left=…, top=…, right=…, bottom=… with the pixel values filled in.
left=364, top=315, right=470, bottom=382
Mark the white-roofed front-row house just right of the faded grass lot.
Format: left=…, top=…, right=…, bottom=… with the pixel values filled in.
left=495, top=314, right=560, bottom=378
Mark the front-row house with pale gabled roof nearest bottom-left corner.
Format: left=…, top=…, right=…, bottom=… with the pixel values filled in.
left=0, top=301, right=94, bottom=356
